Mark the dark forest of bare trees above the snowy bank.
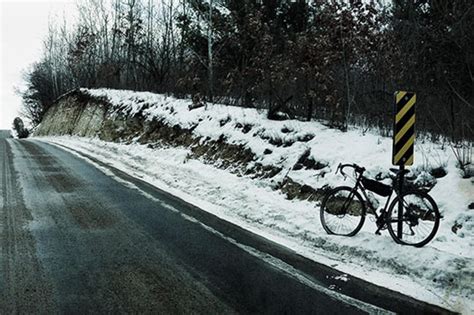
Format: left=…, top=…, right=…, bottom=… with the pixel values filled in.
left=20, top=0, right=474, bottom=146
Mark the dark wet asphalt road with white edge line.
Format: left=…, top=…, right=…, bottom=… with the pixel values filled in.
left=0, top=131, right=454, bottom=314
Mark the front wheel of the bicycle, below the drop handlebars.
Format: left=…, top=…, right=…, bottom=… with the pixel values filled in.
left=320, top=186, right=365, bottom=236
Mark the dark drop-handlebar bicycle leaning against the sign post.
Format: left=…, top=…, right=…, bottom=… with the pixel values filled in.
left=320, top=164, right=441, bottom=247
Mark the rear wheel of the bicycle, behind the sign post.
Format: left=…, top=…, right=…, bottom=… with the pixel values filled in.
left=387, top=191, right=441, bottom=247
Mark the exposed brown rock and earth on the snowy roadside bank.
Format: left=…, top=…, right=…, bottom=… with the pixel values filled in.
left=35, top=90, right=325, bottom=200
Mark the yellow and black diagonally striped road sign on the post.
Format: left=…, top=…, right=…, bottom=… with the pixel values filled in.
left=392, top=91, right=416, bottom=165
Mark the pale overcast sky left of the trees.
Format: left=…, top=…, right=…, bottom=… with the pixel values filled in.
left=0, top=0, right=75, bottom=129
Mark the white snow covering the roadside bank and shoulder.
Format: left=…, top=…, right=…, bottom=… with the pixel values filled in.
left=36, top=90, right=474, bottom=313
